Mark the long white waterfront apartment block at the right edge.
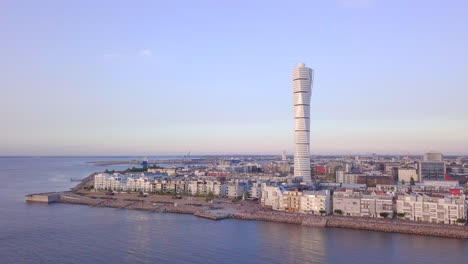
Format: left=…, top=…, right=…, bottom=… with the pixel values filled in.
left=396, top=193, right=467, bottom=224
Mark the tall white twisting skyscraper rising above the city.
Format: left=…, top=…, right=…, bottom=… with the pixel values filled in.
left=293, top=63, right=314, bottom=182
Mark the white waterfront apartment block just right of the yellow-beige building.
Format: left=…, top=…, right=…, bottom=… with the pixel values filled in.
left=300, top=190, right=332, bottom=214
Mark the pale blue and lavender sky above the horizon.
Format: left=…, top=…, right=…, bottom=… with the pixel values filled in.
left=0, top=0, right=468, bottom=156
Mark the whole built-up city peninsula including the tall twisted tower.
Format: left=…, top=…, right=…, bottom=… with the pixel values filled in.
left=26, top=63, right=468, bottom=239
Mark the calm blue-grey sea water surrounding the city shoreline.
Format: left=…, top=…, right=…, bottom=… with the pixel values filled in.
left=0, top=158, right=468, bottom=264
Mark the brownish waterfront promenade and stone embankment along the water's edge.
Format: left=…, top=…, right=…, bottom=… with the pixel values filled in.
left=54, top=192, right=468, bottom=239
